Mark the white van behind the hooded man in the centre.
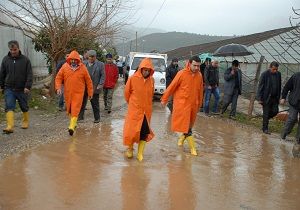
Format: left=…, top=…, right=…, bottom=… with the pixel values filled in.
left=127, top=52, right=167, bottom=95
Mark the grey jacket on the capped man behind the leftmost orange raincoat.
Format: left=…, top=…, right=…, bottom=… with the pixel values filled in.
left=83, top=60, right=105, bottom=94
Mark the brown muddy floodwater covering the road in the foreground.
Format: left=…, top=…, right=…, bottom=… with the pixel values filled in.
left=0, top=103, right=300, bottom=210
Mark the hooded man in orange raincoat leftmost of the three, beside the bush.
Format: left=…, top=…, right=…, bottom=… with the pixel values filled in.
left=55, top=50, right=93, bottom=136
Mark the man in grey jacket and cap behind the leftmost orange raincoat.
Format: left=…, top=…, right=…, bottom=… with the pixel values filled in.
left=78, top=50, right=105, bottom=123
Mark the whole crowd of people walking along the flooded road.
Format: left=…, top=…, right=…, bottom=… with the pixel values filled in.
left=0, top=40, right=300, bottom=161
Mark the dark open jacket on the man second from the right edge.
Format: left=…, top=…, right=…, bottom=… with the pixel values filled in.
left=256, top=69, right=281, bottom=103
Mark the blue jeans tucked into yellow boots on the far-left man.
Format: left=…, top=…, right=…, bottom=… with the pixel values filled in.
left=4, top=88, right=29, bottom=112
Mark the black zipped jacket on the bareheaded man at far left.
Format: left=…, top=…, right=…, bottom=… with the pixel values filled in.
left=0, top=51, right=32, bottom=90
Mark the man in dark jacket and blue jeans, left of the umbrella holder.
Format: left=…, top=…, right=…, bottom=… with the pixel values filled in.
left=204, top=60, right=220, bottom=115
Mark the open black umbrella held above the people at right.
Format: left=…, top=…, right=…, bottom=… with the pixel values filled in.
left=213, top=44, right=253, bottom=57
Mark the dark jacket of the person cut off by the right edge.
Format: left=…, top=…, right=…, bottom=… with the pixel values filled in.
left=281, top=72, right=300, bottom=109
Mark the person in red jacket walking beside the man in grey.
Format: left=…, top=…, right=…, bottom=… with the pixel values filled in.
left=103, top=53, right=119, bottom=114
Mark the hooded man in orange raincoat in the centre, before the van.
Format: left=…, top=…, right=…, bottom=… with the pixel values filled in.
left=123, top=58, right=154, bottom=161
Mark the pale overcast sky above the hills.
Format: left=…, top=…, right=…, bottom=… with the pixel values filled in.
left=134, top=0, right=300, bottom=35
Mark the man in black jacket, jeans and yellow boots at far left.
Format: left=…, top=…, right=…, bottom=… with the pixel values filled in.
left=0, top=40, right=32, bottom=134
